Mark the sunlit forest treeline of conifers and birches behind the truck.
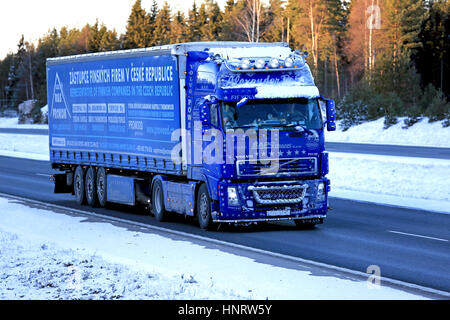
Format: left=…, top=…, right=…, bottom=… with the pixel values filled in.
left=0, top=0, right=450, bottom=128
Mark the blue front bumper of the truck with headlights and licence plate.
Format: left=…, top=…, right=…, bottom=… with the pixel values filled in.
left=212, top=178, right=329, bottom=223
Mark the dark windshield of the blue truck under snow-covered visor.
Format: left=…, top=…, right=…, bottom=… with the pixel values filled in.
left=221, top=98, right=322, bottom=130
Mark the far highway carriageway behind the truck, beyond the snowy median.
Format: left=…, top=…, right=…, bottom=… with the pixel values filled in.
left=0, top=128, right=450, bottom=159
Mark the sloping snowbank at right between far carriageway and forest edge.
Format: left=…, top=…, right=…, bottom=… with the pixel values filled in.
left=325, top=118, right=450, bottom=148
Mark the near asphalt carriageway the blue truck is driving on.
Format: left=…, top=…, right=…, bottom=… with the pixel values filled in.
left=0, top=157, right=450, bottom=292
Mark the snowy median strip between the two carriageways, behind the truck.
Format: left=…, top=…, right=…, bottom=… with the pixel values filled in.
left=0, top=134, right=450, bottom=213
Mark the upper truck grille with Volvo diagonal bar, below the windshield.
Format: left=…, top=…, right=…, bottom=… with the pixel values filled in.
left=236, top=158, right=317, bottom=176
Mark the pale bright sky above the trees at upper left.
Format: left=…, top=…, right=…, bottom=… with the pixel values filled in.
left=0, top=0, right=225, bottom=59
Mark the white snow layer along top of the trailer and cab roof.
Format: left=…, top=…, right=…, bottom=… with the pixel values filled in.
left=47, top=41, right=292, bottom=64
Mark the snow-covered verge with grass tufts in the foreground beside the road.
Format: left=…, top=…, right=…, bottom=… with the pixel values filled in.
left=0, top=198, right=422, bottom=300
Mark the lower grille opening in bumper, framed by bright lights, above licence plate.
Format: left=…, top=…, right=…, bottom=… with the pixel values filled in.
left=248, top=184, right=308, bottom=204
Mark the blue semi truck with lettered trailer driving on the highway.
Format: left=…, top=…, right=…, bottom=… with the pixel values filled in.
left=47, top=42, right=335, bottom=229
